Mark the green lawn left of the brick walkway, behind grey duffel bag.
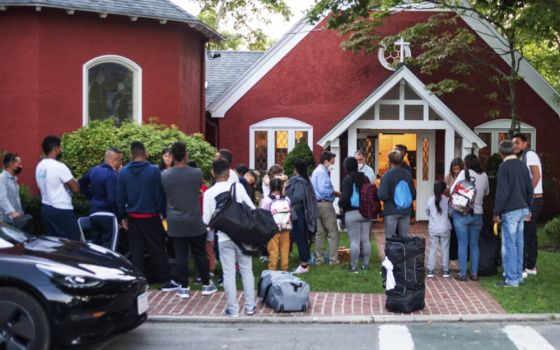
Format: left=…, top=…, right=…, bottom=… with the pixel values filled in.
left=150, top=232, right=385, bottom=293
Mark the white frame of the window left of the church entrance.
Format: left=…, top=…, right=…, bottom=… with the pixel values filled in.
left=249, top=118, right=313, bottom=169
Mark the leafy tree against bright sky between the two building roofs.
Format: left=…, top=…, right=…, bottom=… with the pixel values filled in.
left=194, top=0, right=292, bottom=51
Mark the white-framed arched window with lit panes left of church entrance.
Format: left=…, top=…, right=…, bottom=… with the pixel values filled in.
left=249, top=118, right=313, bottom=171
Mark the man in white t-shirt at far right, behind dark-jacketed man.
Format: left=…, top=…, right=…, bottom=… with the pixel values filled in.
left=513, top=133, right=543, bottom=275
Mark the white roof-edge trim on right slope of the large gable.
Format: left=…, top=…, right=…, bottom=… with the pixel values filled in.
left=457, top=6, right=560, bottom=117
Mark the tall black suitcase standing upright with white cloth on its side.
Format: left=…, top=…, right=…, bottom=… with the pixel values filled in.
left=383, top=237, right=426, bottom=313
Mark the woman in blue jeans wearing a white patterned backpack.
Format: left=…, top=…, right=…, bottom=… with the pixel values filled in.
left=449, top=154, right=490, bottom=281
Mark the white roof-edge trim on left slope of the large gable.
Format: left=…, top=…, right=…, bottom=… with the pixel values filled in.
left=207, top=18, right=321, bottom=118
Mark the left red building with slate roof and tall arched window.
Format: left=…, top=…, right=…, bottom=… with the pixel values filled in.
left=0, top=0, right=220, bottom=185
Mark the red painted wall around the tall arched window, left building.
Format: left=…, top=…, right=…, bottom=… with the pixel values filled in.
left=0, top=7, right=205, bottom=186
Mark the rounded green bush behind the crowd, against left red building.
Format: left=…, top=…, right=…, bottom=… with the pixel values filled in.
left=62, top=121, right=216, bottom=179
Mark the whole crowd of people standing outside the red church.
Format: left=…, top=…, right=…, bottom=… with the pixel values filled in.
left=0, top=134, right=543, bottom=317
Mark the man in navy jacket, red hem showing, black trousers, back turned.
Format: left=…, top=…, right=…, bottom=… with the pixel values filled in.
left=117, top=141, right=179, bottom=292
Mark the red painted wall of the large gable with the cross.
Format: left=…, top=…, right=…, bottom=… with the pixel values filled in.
left=220, top=12, right=560, bottom=185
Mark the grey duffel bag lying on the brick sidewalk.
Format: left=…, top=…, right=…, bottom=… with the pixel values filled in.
left=257, top=270, right=310, bottom=312
